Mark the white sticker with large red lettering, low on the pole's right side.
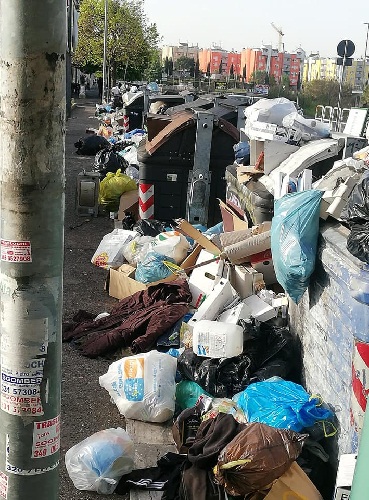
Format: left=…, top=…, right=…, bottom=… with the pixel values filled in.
left=32, top=415, right=60, bottom=458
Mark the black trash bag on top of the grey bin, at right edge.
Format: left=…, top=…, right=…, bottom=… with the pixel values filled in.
left=341, top=171, right=369, bottom=264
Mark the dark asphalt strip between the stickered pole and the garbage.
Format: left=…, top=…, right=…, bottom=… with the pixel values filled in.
left=60, top=98, right=124, bottom=500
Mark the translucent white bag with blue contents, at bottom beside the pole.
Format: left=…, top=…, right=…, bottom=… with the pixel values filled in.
left=65, top=427, right=134, bottom=494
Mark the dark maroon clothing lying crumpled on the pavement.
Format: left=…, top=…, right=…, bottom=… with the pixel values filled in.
left=63, top=279, right=191, bottom=358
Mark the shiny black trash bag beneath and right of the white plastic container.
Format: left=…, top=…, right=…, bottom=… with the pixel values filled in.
left=178, top=320, right=296, bottom=398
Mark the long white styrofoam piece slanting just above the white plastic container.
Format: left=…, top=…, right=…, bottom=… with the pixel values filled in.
left=188, top=278, right=237, bottom=328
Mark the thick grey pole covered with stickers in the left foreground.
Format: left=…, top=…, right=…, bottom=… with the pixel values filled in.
left=0, top=0, right=67, bottom=500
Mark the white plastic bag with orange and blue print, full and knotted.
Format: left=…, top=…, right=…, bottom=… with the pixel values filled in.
left=99, top=351, right=177, bottom=422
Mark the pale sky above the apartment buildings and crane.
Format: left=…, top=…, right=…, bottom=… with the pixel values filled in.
left=144, top=0, right=369, bottom=58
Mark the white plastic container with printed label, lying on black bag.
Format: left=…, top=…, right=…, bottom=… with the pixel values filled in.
left=193, top=320, right=243, bottom=358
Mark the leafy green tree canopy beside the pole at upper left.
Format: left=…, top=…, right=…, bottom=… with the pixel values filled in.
left=73, top=0, right=159, bottom=81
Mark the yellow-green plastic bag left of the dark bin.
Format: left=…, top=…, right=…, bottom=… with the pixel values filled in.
left=99, top=169, right=137, bottom=212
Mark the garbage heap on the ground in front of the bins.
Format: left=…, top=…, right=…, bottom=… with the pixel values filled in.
left=64, top=213, right=336, bottom=500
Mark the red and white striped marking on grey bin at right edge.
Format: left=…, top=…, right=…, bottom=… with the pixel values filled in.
left=351, top=341, right=369, bottom=432
